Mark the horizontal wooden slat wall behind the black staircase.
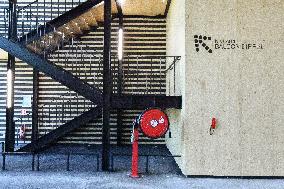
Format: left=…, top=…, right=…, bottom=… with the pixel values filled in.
left=0, top=1, right=166, bottom=144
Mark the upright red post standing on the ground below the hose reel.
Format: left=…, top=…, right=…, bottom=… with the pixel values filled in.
left=130, top=127, right=139, bottom=178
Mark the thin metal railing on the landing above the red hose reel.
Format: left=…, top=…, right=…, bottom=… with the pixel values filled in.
left=112, top=55, right=180, bottom=95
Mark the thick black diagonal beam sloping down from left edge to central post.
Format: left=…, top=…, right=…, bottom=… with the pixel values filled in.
left=0, top=36, right=102, bottom=105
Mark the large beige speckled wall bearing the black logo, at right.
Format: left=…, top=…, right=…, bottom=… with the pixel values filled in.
left=168, top=0, right=284, bottom=176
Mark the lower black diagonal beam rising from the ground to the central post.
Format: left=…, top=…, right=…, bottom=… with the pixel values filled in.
left=18, top=107, right=101, bottom=152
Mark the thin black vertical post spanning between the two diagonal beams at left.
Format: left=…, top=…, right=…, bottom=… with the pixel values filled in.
left=32, top=69, right=39, bottom=142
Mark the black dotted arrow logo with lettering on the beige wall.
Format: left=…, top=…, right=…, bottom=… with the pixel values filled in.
left=194, top=35, right=264, bottom=53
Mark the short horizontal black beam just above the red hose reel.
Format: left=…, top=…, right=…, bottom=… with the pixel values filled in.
left=111, top=95, right=182, bottom=110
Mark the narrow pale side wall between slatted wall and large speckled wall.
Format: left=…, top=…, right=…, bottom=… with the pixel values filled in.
left=166, top=0, right=185, bottom=165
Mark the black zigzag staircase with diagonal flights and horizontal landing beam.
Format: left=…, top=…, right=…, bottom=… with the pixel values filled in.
left=0, top=0, right=181, bottom=155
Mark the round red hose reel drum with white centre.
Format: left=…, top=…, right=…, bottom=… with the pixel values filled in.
left=139, top=109, right=169, bottom=139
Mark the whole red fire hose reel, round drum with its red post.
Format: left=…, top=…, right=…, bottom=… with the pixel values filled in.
left=131, top=108, right=169, bottom=178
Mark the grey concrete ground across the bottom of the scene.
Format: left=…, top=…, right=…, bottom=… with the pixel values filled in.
left=0, top=145, right=284, bottom=189
